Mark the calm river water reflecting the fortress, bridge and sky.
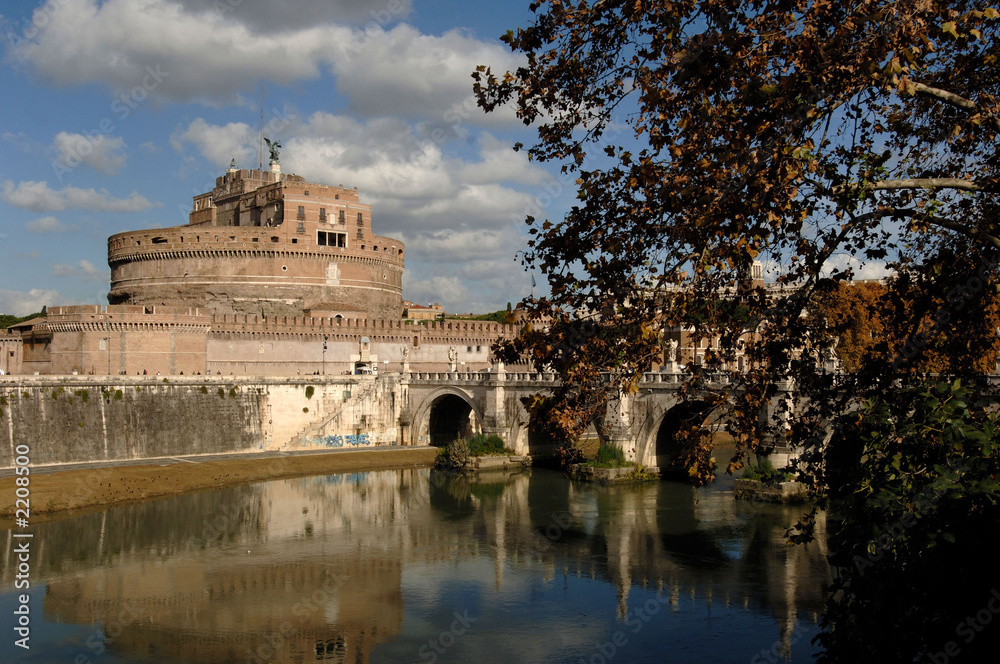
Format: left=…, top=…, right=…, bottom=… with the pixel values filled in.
left=0, top=469, right=830, bottom=664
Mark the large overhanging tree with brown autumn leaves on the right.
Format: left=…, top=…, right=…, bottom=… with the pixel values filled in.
left=474, top=0, right=1000, bottom=661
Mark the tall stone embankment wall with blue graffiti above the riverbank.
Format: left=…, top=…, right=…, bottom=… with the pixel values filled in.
left=0, top=376, right=399, bottom=468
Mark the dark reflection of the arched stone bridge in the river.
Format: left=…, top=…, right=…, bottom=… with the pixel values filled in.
left=432, top=469, right=829, bottom=631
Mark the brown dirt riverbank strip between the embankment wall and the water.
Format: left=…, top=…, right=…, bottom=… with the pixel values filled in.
left=0, top=448, right=437, bottom=528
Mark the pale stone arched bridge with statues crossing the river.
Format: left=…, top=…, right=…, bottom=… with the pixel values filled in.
left=401, top=365, right=786, bottom=468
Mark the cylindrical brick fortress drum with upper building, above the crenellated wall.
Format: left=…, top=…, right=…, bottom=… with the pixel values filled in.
left=108, top=170, right=403, bottom=319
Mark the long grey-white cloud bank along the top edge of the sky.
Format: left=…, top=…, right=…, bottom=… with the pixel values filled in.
left=10, top=0, right=518, bottom=123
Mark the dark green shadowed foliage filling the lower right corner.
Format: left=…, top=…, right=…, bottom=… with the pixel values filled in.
left=819, top=381, right=1000, bottom=662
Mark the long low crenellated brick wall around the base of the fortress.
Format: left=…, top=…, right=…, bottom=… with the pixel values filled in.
left=7, top=305, right=518, bottom=376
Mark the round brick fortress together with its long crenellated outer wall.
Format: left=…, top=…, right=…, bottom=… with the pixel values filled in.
left=0, top=151, right=513, bottom=376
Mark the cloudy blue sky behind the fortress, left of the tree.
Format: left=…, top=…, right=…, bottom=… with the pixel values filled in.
left=0, top=0, right=572, bottom=314
